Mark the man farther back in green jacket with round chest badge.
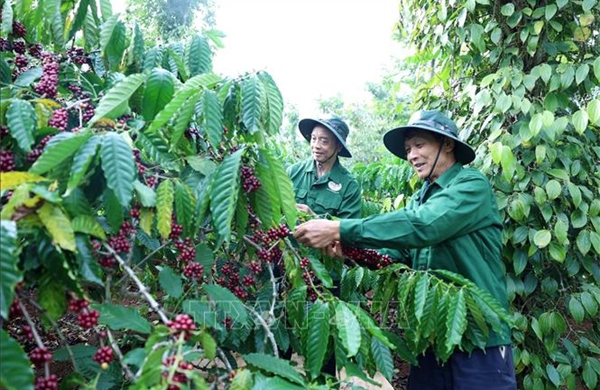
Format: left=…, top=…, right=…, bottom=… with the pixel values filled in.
left=287, top=117, right=361, bottom=218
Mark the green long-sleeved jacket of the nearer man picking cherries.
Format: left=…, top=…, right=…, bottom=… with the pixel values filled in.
left=340, top=163, right=510, bottom=347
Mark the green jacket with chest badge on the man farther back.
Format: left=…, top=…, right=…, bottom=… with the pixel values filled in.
left=287, top=159, right=362, bottom=218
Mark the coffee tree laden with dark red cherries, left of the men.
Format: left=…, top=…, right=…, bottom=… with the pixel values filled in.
left=0, top=0, right=509, bottom=389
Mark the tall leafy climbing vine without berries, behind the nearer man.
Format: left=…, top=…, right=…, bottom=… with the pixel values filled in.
left=400, top=0, right=600, bottom=389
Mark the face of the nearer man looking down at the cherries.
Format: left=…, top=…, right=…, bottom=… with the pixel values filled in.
left=404, top=130, right=456, bottom=181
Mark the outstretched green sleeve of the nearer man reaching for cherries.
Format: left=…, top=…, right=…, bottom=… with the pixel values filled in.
left=340, top=175, right=492, bottom=250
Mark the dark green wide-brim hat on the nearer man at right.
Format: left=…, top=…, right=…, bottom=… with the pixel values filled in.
left=383, top=110, right=475, bottom=164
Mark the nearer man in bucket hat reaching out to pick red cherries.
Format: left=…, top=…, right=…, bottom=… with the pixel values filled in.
left=294, top=110, right=516, bottom=390
